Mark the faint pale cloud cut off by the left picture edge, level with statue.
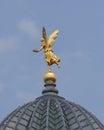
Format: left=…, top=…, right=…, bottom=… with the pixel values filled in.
left=0, top=36, right=18, bottom=53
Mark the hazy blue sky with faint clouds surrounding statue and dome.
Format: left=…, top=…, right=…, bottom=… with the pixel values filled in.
left=0, top=0, right=104, bottom=124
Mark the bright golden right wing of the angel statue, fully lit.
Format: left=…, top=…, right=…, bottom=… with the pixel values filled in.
left=47, top=30, right=59, bottom=47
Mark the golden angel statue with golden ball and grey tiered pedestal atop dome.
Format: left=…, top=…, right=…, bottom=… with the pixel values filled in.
left=33, top=27, right=60, bottom=94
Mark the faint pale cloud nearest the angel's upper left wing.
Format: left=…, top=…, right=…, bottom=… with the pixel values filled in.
left=18, top=19, right=39, bottom=38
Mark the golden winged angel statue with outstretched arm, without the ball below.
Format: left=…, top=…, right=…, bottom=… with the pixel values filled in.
left=33, top=27, right=60, bottom=70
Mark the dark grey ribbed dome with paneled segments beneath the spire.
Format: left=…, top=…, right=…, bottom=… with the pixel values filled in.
left=0, top=94, right=104, bottom=130
